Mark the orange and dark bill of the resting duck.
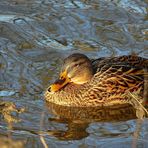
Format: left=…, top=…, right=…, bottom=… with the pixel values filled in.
left=49, top=71, right=70, bottom=92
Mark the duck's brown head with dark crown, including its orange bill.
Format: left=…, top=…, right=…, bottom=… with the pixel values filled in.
left=48, top=53, right=93, bottom=92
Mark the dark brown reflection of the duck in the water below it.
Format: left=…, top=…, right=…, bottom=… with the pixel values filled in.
left=47, top=103, right=136, bottom=140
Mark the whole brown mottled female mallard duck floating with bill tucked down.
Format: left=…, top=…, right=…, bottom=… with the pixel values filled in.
left=45, top=53, right=148, bottom=107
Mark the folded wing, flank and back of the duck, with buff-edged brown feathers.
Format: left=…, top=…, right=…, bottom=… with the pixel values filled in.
left=88, top=55, right=148, bottom=103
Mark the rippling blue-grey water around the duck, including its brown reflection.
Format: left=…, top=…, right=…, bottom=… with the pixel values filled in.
left=0, top=0, right=148, bottom=148
